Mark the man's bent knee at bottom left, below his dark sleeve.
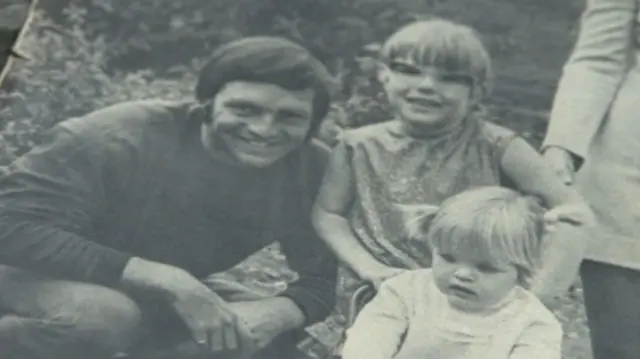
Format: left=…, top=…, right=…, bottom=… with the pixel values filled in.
left=0, top=266, right=141, bottom=351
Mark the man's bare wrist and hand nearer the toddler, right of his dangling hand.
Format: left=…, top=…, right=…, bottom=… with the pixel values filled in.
left=229, top=297, right=304, bottom=350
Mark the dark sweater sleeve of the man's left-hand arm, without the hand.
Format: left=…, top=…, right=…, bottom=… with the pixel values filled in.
left=0, top=118, right=131, bottom=285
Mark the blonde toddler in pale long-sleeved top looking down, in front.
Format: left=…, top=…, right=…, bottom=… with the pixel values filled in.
left=343, top=187, right=562, bottom=359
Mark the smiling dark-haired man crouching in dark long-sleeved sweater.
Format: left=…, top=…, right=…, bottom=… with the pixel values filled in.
left=0, top=37, right=336, bottom=359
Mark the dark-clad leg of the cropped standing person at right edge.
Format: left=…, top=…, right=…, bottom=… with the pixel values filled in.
left=580, top=260, right=640, bottom=359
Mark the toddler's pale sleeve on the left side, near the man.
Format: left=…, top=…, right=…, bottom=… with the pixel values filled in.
left=342, top=272, right=413, bottom=359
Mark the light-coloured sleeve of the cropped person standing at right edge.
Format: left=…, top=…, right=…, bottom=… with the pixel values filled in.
left=543, top=0, right=638, bottom=159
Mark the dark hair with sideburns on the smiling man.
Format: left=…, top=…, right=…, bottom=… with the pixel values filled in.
left=195, top=36, right=335, bottom=134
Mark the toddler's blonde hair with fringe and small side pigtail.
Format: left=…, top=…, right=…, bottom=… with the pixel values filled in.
left=412, top=187, right=544, bottom=287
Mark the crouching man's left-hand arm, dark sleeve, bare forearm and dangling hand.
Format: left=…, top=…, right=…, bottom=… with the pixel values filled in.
left=0, top=104, right=250, bottom=354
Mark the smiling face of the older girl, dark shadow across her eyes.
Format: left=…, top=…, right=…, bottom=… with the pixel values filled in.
left=378, top=59, right=475, bottom=135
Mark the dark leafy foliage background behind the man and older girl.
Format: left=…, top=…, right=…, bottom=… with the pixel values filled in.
left=0, top=0, right=590, bottom=359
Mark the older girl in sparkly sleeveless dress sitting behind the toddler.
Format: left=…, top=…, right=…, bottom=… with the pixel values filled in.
left=302, top=19, right=588, bottom=359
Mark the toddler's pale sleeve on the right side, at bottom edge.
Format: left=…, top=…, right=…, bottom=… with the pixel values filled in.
left=509, top=318, right=563, bottom=359
